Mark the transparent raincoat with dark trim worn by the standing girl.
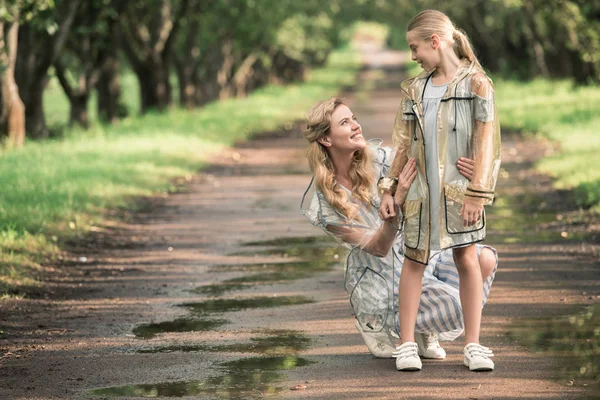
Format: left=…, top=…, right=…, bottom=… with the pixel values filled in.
left=388, top=60, right=500, bottom=264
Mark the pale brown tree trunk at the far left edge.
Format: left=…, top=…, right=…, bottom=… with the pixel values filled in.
left=0, top=18, right=25, bottom=147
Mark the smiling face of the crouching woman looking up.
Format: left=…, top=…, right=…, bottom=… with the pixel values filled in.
left=321, top=104, right=367, bottom=152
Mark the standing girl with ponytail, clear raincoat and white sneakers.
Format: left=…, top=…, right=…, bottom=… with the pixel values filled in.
left=380, top=10, right=500, bottom=371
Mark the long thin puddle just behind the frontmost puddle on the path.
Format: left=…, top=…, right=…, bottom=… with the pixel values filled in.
left=137, top=330, right=310, bottom=355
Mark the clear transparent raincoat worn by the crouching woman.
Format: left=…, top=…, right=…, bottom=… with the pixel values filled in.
left=301, top=140, right=496, bottom=357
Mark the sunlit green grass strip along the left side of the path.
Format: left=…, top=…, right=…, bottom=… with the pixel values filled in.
left=0, top=50, right=359, bottom=295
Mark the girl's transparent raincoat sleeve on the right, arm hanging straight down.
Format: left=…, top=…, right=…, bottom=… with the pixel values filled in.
left=465, top=73, right=501, bottom=205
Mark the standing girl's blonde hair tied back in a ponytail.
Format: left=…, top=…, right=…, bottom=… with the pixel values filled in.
left=406, top=10, right=482, bottom=69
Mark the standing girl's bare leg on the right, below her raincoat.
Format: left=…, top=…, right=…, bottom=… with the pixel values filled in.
left=452, top=245, right=483, bottom=344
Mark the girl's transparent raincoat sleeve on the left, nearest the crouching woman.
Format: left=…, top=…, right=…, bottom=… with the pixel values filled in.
left=379, top=91, right=416, bottom=192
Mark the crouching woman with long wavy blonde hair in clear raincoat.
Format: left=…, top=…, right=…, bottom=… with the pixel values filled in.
left=302, top=98, right=497, bottom=368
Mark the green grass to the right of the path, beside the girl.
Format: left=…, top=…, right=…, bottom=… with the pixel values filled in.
left=495, top=78, right=600, bottom=212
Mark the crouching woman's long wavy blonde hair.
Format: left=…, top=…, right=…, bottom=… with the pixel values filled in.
left=304, top=97, right=374, bottom=220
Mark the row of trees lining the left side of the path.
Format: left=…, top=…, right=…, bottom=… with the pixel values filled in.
left=0, top=0, right=338, bottom=144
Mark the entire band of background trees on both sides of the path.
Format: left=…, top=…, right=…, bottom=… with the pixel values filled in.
left=0, top=0, right=600, bottom=144
